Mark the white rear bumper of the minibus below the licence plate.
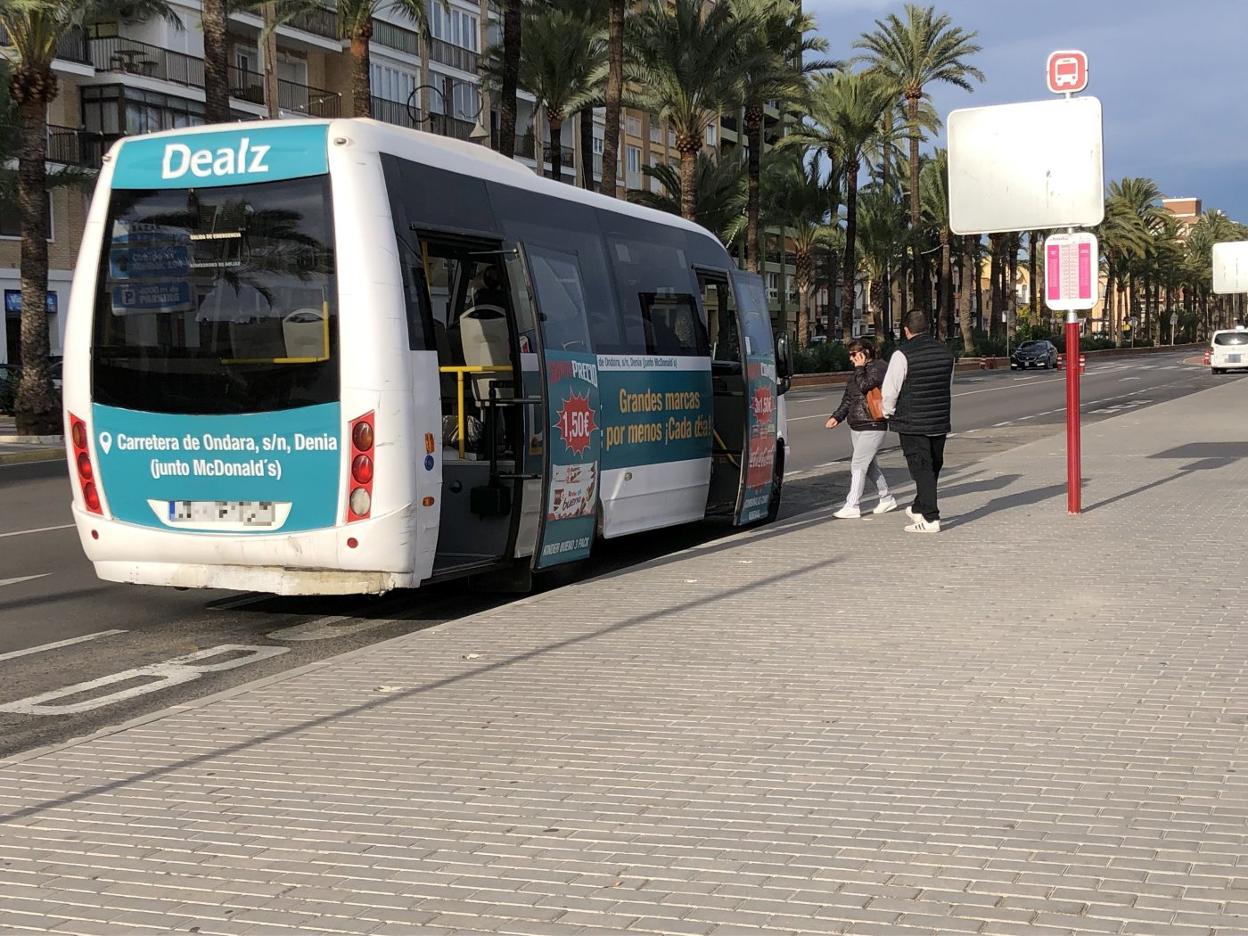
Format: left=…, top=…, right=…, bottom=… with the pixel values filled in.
left=74, top=503, right=419, bottom=595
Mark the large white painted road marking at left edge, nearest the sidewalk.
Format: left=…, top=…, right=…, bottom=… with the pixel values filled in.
left=0, top=644, right=291, bottom=715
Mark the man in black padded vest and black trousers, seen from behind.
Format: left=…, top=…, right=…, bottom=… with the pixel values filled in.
left=884, top=308, right=953, bottom=533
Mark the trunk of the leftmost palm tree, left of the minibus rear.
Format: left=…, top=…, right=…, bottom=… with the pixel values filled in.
left=14, top=86, right=61, bottom=436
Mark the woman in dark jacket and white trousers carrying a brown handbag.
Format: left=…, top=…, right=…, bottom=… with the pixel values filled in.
left=826, top=338, right=897, bottom=520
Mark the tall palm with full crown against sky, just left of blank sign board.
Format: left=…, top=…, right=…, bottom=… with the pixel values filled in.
left=854, top=4, right=983, bottom=316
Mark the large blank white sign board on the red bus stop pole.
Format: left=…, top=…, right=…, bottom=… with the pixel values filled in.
left=948, top=97, right=1104, bottom=235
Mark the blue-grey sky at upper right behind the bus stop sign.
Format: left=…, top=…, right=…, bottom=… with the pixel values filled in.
left=802, top=0, right=1248, bottom=222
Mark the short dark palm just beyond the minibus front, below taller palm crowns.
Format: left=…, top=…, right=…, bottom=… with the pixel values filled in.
left=764, top=151, right=835, bottom=348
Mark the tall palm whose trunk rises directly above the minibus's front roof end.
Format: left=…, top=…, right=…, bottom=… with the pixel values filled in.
left=731, top=0, right=839, bottom=273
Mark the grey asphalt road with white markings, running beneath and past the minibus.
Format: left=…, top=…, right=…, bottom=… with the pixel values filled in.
left=0, top=356, right=1239, bottom=756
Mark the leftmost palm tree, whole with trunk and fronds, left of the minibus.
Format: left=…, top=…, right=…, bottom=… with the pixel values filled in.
left=0, top=0, right=181, bottom=436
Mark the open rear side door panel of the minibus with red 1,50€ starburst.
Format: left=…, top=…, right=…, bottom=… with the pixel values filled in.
left=517, top=245, right=602, bottom=570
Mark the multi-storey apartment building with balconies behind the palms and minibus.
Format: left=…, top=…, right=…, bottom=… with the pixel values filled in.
left=0, top=0, right=796, bottom=363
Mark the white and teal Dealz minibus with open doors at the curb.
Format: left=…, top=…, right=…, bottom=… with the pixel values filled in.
left=64, top=120, right=789, bottom=594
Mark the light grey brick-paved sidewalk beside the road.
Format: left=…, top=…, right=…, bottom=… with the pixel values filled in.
left=0, top=381, right=1248, bottom=936
